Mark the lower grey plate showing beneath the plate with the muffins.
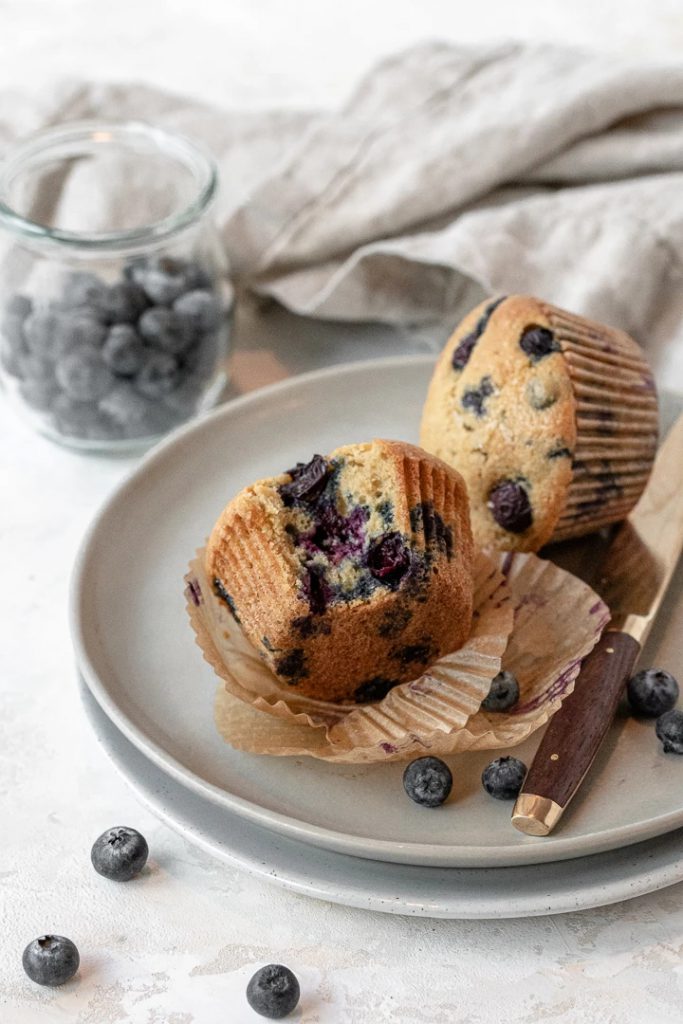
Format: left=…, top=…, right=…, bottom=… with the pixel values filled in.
left=82, top=686, right=683, bottom=919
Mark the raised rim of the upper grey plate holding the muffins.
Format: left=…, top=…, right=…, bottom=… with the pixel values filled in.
left=69, top=353, right=683, bottom=867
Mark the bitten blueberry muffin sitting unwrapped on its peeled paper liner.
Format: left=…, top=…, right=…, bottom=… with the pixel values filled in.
left=205, top=440, right=473, bottom=702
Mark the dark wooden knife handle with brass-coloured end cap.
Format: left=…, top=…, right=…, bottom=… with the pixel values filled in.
left=512, top=631, right=640, bottom=836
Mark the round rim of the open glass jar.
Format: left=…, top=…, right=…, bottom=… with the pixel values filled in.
left=0, top=120, right=218, bottom=251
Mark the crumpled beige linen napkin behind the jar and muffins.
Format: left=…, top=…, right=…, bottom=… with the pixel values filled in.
left=0, top=42, right=683, bottom=386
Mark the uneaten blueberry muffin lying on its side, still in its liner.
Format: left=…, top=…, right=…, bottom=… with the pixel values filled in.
left=421, top=295, right=657, bottom=551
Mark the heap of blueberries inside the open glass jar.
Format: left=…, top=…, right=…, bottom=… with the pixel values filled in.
left=0, top=257, right=226, bottom=440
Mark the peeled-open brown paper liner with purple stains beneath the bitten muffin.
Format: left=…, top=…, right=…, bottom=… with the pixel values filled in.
left=185, top=551, right=609, bottom=764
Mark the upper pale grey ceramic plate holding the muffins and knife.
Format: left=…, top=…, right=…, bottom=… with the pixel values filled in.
left=72, top=356, right=683, bottom=866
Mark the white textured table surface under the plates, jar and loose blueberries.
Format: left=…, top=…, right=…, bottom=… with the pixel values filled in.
left=0, top=0, right=683, bottom=1024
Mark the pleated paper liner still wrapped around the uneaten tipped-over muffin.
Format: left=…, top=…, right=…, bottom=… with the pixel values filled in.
left=545, top=306, right=658, bottom=541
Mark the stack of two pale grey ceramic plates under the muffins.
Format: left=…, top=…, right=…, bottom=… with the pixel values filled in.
left=72, top=356, right=683, bottom=918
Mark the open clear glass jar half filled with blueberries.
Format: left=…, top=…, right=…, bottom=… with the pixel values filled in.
left=0, top=122, right=232, bottom=451
